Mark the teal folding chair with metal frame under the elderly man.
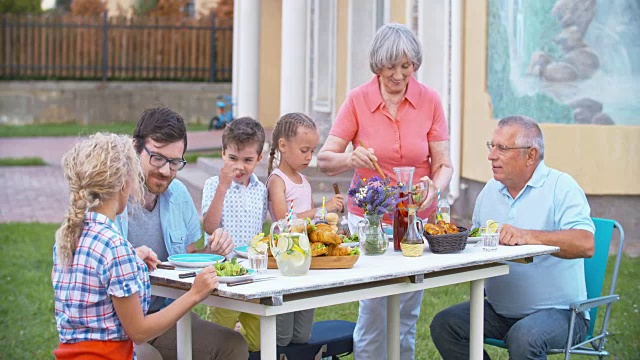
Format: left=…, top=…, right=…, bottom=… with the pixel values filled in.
left=484, top=218, right=624, bottom=360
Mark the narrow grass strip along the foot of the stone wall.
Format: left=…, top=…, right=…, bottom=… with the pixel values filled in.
left=0, top=122, right=207, bottom=138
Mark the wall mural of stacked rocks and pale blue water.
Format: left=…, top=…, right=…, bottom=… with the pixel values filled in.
left=487, top=0, right=640, bottom=125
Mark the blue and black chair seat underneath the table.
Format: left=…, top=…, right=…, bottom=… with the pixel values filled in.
left=249, top=320, right=356, bottom=360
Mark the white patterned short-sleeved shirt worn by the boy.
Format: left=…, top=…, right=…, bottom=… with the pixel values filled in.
left=202, top=174, right=267, bottom=246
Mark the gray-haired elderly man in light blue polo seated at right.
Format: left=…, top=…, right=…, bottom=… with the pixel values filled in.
left=431, top=116, right=595, bottom=360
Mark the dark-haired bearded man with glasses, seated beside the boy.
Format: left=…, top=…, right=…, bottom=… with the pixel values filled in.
left=116, top=107, right=248, bottom=360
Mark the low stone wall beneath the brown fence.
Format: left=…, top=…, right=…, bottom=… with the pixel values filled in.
left=0, top=81, right=231, bottom=124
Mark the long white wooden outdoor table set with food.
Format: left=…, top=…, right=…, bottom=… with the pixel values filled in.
left=150, top=244, right=559, bottom=360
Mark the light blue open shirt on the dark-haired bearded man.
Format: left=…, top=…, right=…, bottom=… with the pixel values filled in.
left=116, top=179, right=202, bottom=256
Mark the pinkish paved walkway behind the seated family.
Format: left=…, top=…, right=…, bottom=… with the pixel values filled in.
left=0, top=130, right=640, bottom=256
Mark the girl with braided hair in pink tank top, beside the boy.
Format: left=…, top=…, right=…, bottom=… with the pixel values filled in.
left=267, top=113, right=343, bottom=346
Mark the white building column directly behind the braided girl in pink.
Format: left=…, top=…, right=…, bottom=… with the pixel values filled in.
left=280, top=0, right=308, bottom=115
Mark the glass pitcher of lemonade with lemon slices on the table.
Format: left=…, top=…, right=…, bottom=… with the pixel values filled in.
left=271, top=219, right=311, bottom=276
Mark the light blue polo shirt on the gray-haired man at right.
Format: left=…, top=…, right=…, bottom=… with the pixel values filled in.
left=473, top=161, right=595, bottom=318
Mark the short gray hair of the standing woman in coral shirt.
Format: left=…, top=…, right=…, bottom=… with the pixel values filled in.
left=369, top=24, right=422, bottom=75
